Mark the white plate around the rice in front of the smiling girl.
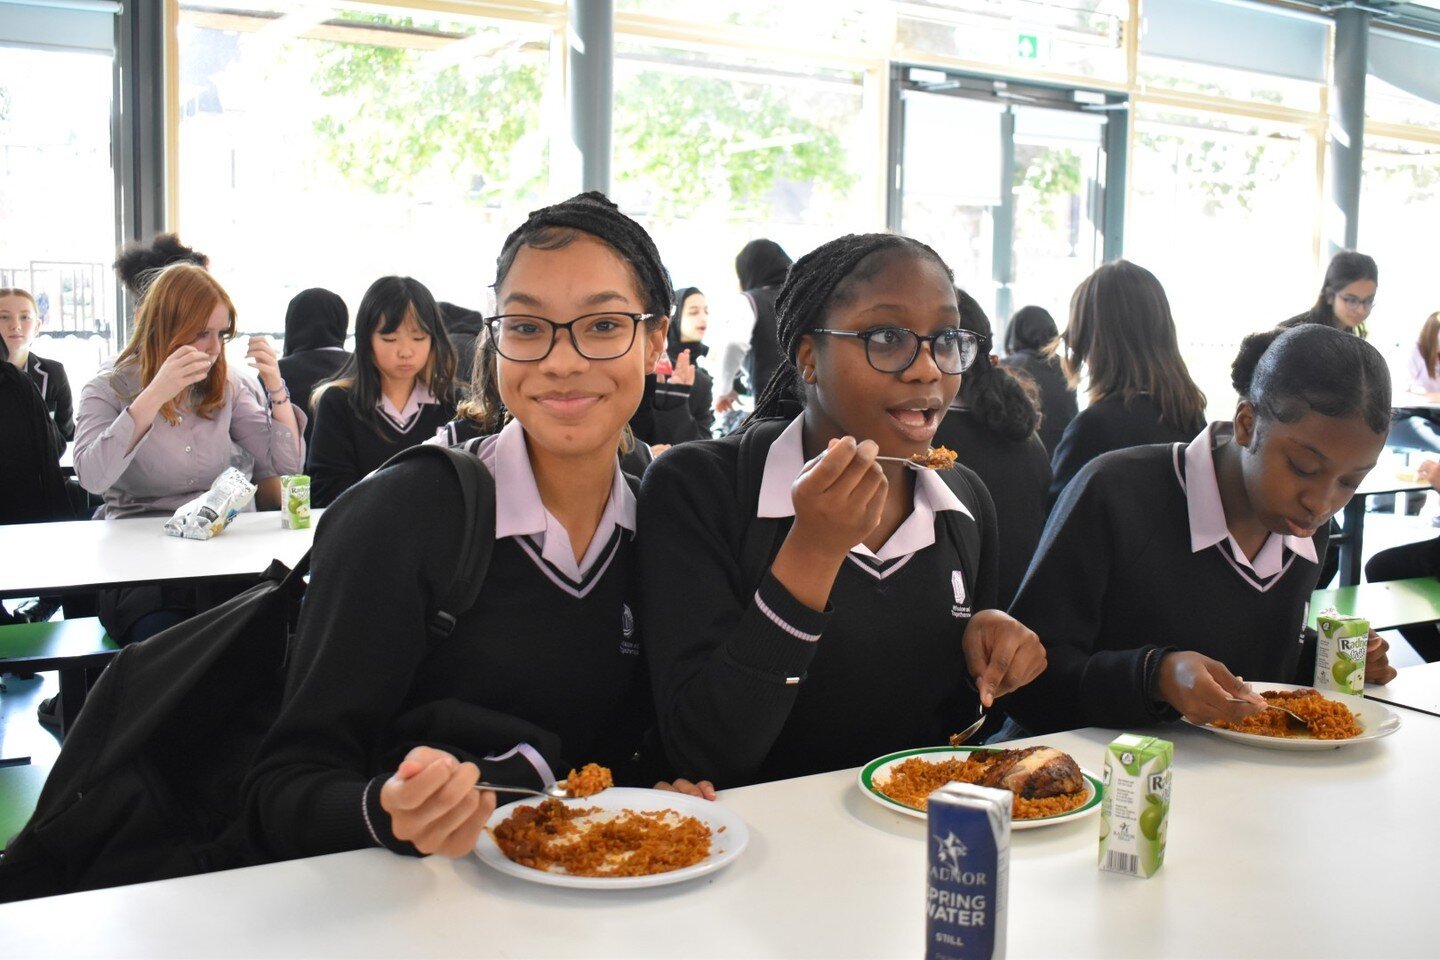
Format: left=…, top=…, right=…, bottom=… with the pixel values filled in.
left=475, top=787, right=750, bottom=889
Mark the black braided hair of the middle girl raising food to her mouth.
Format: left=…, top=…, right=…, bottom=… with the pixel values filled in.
left=746, top=233, right=955, bottom=423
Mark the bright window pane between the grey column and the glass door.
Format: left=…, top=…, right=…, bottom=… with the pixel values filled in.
left=612, top=39, right=864, bottom=359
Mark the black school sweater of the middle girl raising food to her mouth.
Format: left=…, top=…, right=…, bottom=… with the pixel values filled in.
left=636, top=427, right=995, bottom=787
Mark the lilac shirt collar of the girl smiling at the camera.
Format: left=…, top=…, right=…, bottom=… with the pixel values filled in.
left=477, top=420, right=635, bottom=580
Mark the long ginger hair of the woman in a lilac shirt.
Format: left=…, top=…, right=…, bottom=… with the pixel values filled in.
left=115, top=263, right=235, bottom=423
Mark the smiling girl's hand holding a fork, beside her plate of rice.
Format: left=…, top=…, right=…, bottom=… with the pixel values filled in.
left=380, top=747, right=495, bottom=856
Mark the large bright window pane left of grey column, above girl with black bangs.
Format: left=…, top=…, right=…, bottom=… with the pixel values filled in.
left=179, top=3, right=550, bottom=341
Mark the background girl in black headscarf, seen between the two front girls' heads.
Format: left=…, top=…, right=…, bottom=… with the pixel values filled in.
left=631, top=286, right=716, bottom=449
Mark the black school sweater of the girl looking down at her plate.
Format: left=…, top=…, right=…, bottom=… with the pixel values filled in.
left=1007, top=443, right=1328, bottom=733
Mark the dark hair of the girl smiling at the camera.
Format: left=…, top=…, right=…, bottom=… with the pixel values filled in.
left=461, top=190, right=674, bottom=432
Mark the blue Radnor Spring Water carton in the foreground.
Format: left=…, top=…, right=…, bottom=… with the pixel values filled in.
left=924, top=783, right=1014, bottom=960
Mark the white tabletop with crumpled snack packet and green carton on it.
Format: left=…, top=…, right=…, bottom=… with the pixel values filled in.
left=0, top=510, right=324, bottom=597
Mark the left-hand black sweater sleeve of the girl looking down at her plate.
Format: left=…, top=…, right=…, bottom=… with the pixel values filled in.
left=1007, top=461, right=1174, bottom=733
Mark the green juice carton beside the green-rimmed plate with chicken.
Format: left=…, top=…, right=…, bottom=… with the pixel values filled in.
left=1100, top=734, right=1175, bottom=877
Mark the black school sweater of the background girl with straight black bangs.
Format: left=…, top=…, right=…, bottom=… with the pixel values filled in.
left=305, top=387, right=455, bottom=507
